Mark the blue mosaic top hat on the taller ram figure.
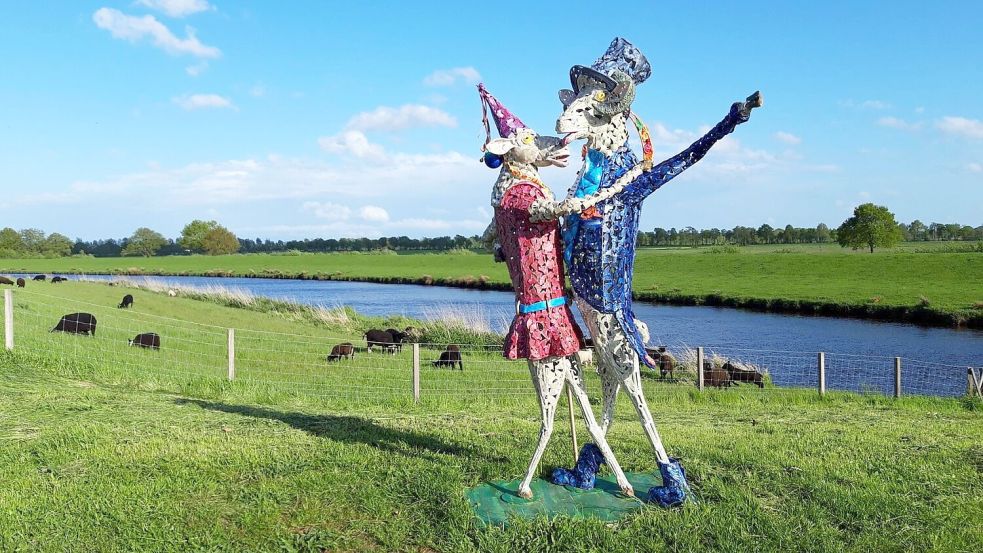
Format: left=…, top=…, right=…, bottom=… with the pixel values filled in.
left=560, top=37, right=652, bottom=112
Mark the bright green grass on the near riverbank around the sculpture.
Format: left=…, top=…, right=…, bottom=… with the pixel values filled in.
left=0, top=282, right=983, bottom=551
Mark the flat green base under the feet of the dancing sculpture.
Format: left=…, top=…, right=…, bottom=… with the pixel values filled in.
left=467, top=472, right=662, bottom=526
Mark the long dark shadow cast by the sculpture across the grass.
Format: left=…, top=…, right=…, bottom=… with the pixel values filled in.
left=174, top=398, right=484, bottom=460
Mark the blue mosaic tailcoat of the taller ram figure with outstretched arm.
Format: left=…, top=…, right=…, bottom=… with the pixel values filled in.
left=564, top=103, right=748, bottom=368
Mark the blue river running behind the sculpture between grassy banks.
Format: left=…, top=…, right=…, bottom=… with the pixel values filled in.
left=32, top=276, right=983, bottom=396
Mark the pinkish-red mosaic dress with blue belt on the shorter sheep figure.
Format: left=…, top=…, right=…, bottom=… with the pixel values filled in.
left=495, top=182, right=582, bottom=361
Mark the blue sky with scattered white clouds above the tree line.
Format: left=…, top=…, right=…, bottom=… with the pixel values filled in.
left=0, top=0, right=983, bottom=239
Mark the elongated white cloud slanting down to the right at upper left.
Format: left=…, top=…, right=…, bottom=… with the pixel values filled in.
left=92, top=8, right=222, bottom=58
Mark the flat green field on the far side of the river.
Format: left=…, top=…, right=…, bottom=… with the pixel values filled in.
left=0, top=243, right=983, bottom=327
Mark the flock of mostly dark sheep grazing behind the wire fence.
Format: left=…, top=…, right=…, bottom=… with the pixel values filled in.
left=0, top=275, right=764, bottom=388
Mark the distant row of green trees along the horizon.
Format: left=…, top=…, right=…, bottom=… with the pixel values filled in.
left=0, top=204, right=983, bottom=257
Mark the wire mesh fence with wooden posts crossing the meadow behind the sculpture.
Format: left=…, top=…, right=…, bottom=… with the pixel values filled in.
left=3, top=290, right=983, bottom=402
